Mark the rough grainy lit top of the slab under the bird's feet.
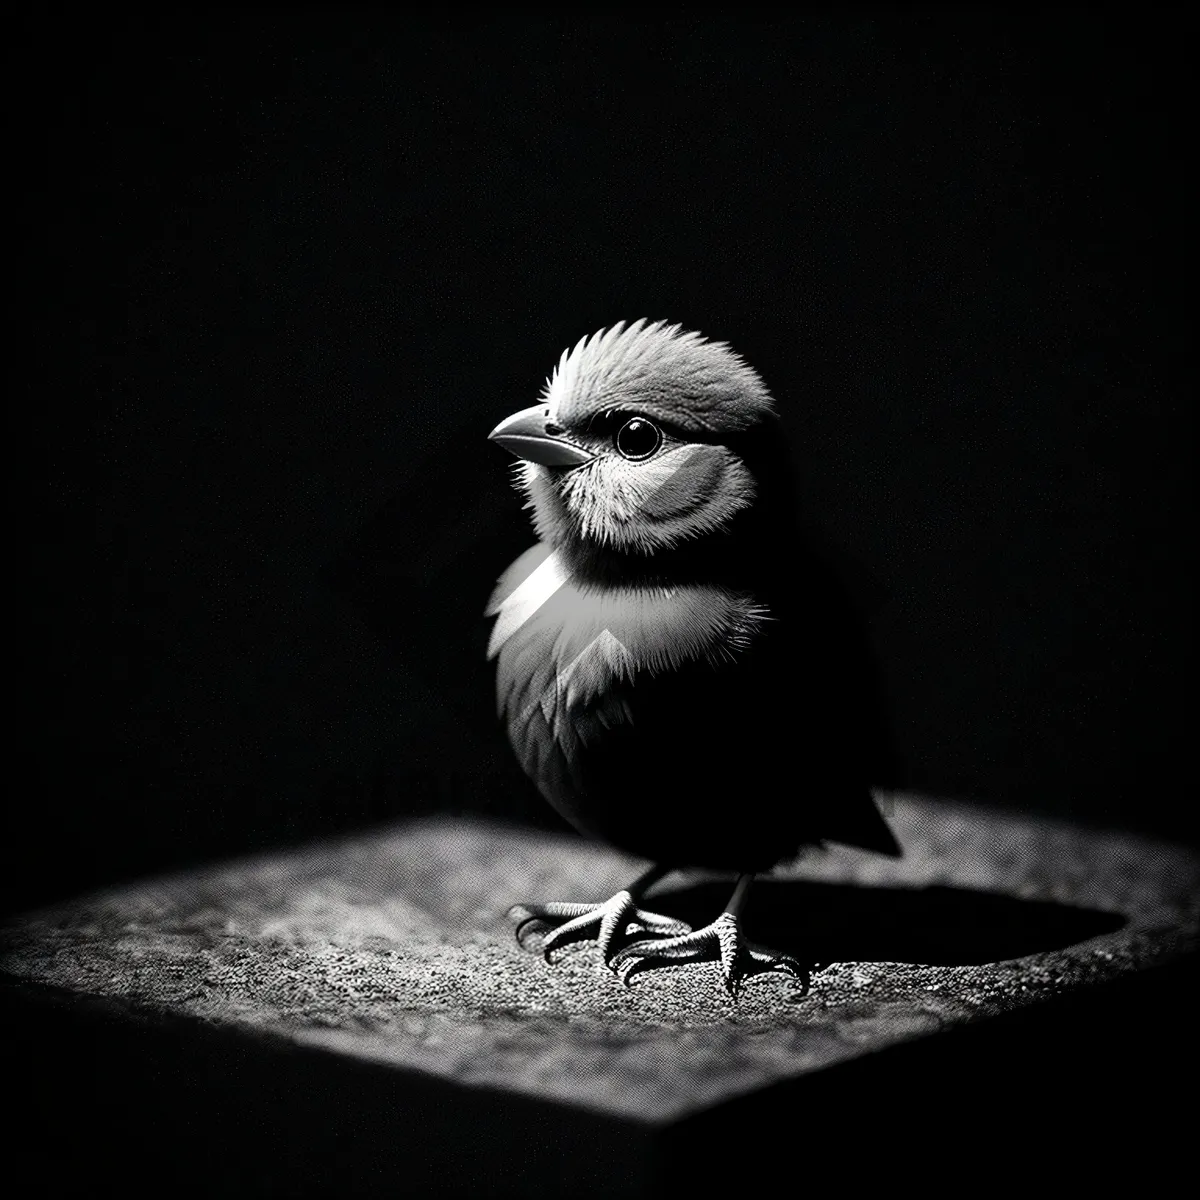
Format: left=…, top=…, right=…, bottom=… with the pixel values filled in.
left=2, top=796, right=1200, bottom=1123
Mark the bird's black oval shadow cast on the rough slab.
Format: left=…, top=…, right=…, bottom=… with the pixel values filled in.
left=642, top=880, right=1126, bottom=966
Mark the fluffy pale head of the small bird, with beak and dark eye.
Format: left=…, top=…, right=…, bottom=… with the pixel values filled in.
left=490, top=320, right=781, bottom=580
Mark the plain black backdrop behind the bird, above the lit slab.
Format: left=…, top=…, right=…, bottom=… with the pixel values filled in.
left=4, top=10, right=1194, bottom=904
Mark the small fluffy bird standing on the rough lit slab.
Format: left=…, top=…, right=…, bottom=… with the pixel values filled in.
left=486, top=320, right=900, bottom=992
